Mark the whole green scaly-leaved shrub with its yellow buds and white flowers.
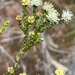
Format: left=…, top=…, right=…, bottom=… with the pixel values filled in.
left=0, top=0, right=73, bottom=75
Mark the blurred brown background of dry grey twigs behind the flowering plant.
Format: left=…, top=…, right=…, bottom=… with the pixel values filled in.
left=0, top=0, right=75, bottom=75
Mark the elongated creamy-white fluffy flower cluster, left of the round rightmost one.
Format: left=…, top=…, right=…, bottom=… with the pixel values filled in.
left=43, top=2, right=60, bottom=24
